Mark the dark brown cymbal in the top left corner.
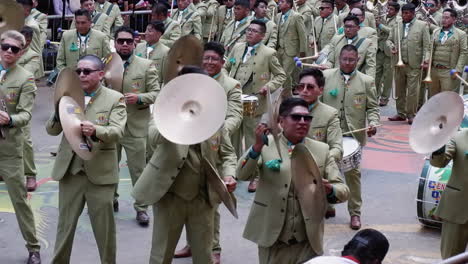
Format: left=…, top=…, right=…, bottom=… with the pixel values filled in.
left=0, top=0, right=24, bottom=34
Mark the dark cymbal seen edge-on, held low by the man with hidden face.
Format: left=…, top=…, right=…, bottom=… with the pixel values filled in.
left=202, top=157, right=239, bottom=219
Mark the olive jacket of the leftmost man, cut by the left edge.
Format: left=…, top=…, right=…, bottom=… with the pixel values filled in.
left=0, top=65, right=37, bottom=159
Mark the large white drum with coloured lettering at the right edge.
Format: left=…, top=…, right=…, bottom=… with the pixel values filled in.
left=416, top=160, right=452, bottom=228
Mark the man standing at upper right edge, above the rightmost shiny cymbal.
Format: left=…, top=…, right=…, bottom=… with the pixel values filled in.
left=424, top=8, right=468, bottom=97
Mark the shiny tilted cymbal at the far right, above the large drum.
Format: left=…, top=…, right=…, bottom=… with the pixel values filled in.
left=409, top=92, right=465, bottom=154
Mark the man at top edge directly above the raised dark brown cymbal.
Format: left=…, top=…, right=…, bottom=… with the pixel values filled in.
left=171, top=0, right=202, bottom=40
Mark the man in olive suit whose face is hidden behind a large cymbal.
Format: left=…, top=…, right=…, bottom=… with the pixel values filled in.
left=132, top=66, right=236, bottom=264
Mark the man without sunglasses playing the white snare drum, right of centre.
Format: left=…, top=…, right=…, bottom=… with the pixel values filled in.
left=322, top=44, right=380, bottom=229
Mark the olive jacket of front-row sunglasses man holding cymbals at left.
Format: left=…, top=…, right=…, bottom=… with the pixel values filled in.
left=46, top=86, right=127, bottom=185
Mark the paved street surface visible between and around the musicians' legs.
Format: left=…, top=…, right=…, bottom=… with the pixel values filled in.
left=0, top=83, right=446, bottom=264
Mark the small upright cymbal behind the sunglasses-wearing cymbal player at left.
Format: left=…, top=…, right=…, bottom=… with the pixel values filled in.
left=104, top=52, right=125, bottom=92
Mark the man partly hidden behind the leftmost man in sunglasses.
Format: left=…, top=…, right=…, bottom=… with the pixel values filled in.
left=17, top=26, right=42, bottom=192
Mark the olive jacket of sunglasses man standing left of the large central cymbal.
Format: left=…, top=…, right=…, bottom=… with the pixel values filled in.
left=123, top=55, right=160, bottom=137
